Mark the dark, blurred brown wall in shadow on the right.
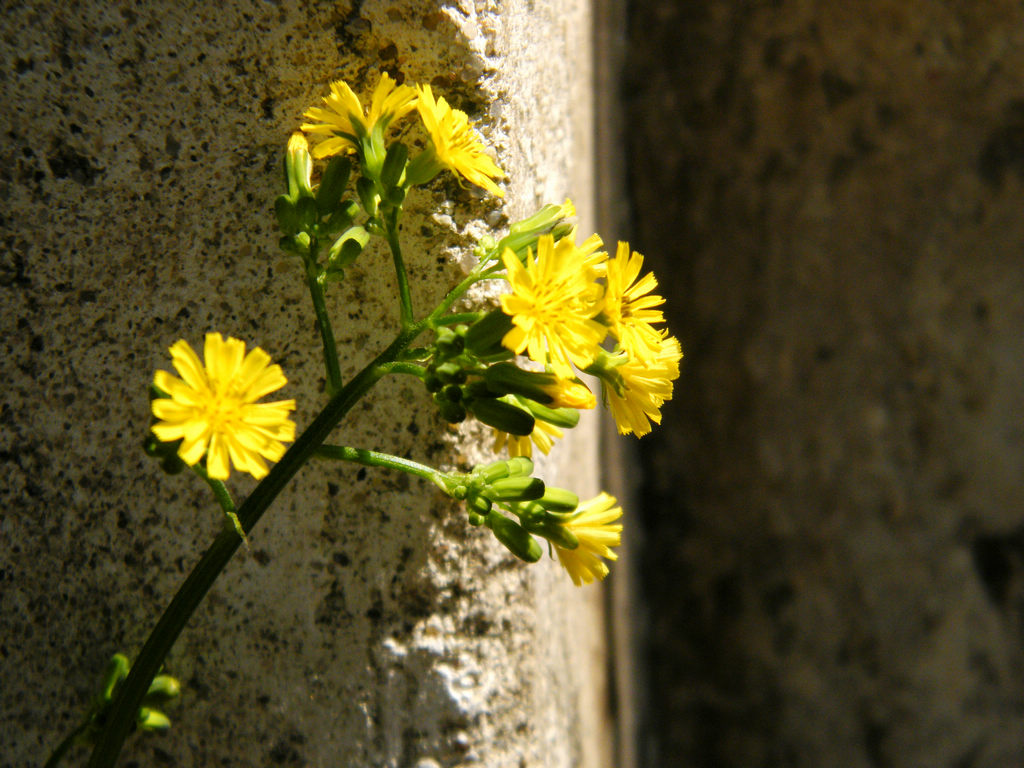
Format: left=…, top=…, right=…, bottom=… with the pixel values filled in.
left=626, top=0, right=1024, bottom=768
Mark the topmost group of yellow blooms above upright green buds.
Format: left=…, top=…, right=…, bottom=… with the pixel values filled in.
left=302, top=73, right=505, bottom=198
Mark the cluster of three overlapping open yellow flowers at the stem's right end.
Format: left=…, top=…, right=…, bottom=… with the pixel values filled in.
left=501, top=234, right=683, bottom=438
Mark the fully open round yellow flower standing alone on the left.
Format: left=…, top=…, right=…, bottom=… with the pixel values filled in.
left=153, top=334, right=295, bottom=480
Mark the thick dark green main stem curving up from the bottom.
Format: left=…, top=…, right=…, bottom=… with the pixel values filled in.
left=88, top=323, right=426, bottom=768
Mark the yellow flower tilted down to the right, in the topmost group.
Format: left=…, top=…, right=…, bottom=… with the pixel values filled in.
left=416, top=85, right=505, bottom=198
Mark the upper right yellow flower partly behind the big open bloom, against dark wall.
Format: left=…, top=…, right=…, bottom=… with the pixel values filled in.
left=604, top=243, right=665, bottom=353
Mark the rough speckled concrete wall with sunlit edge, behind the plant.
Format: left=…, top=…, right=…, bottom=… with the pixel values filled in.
left=0, top=0, right=606, bottom=768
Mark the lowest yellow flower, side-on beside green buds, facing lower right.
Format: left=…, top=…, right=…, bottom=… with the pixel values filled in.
left=555, top=492, right=623, bottom=587
